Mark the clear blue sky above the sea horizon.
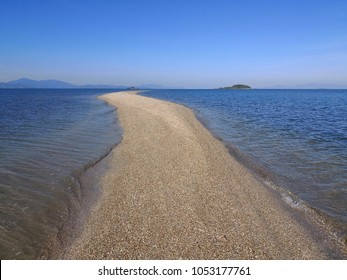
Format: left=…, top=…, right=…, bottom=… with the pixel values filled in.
left=0, top=0, right=347, bottom=88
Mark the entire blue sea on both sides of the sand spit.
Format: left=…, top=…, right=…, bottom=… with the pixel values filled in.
left=0, top=89, right=347, bottom=259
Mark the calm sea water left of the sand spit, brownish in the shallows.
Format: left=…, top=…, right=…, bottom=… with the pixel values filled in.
left=0, top=89, right=121, bottom=259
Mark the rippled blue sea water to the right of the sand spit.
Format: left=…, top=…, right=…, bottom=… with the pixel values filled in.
left=143, top=89, right=347, bottom=232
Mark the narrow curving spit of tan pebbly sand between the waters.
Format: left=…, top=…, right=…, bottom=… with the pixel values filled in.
left=65, top=92, right=334, bottom=259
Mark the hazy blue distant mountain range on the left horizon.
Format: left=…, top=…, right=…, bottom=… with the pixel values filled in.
left=0, top=78, right=162, bottom=89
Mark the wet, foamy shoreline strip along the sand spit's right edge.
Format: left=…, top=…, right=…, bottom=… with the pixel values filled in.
left=193, top=110, right=347, bottom=253
